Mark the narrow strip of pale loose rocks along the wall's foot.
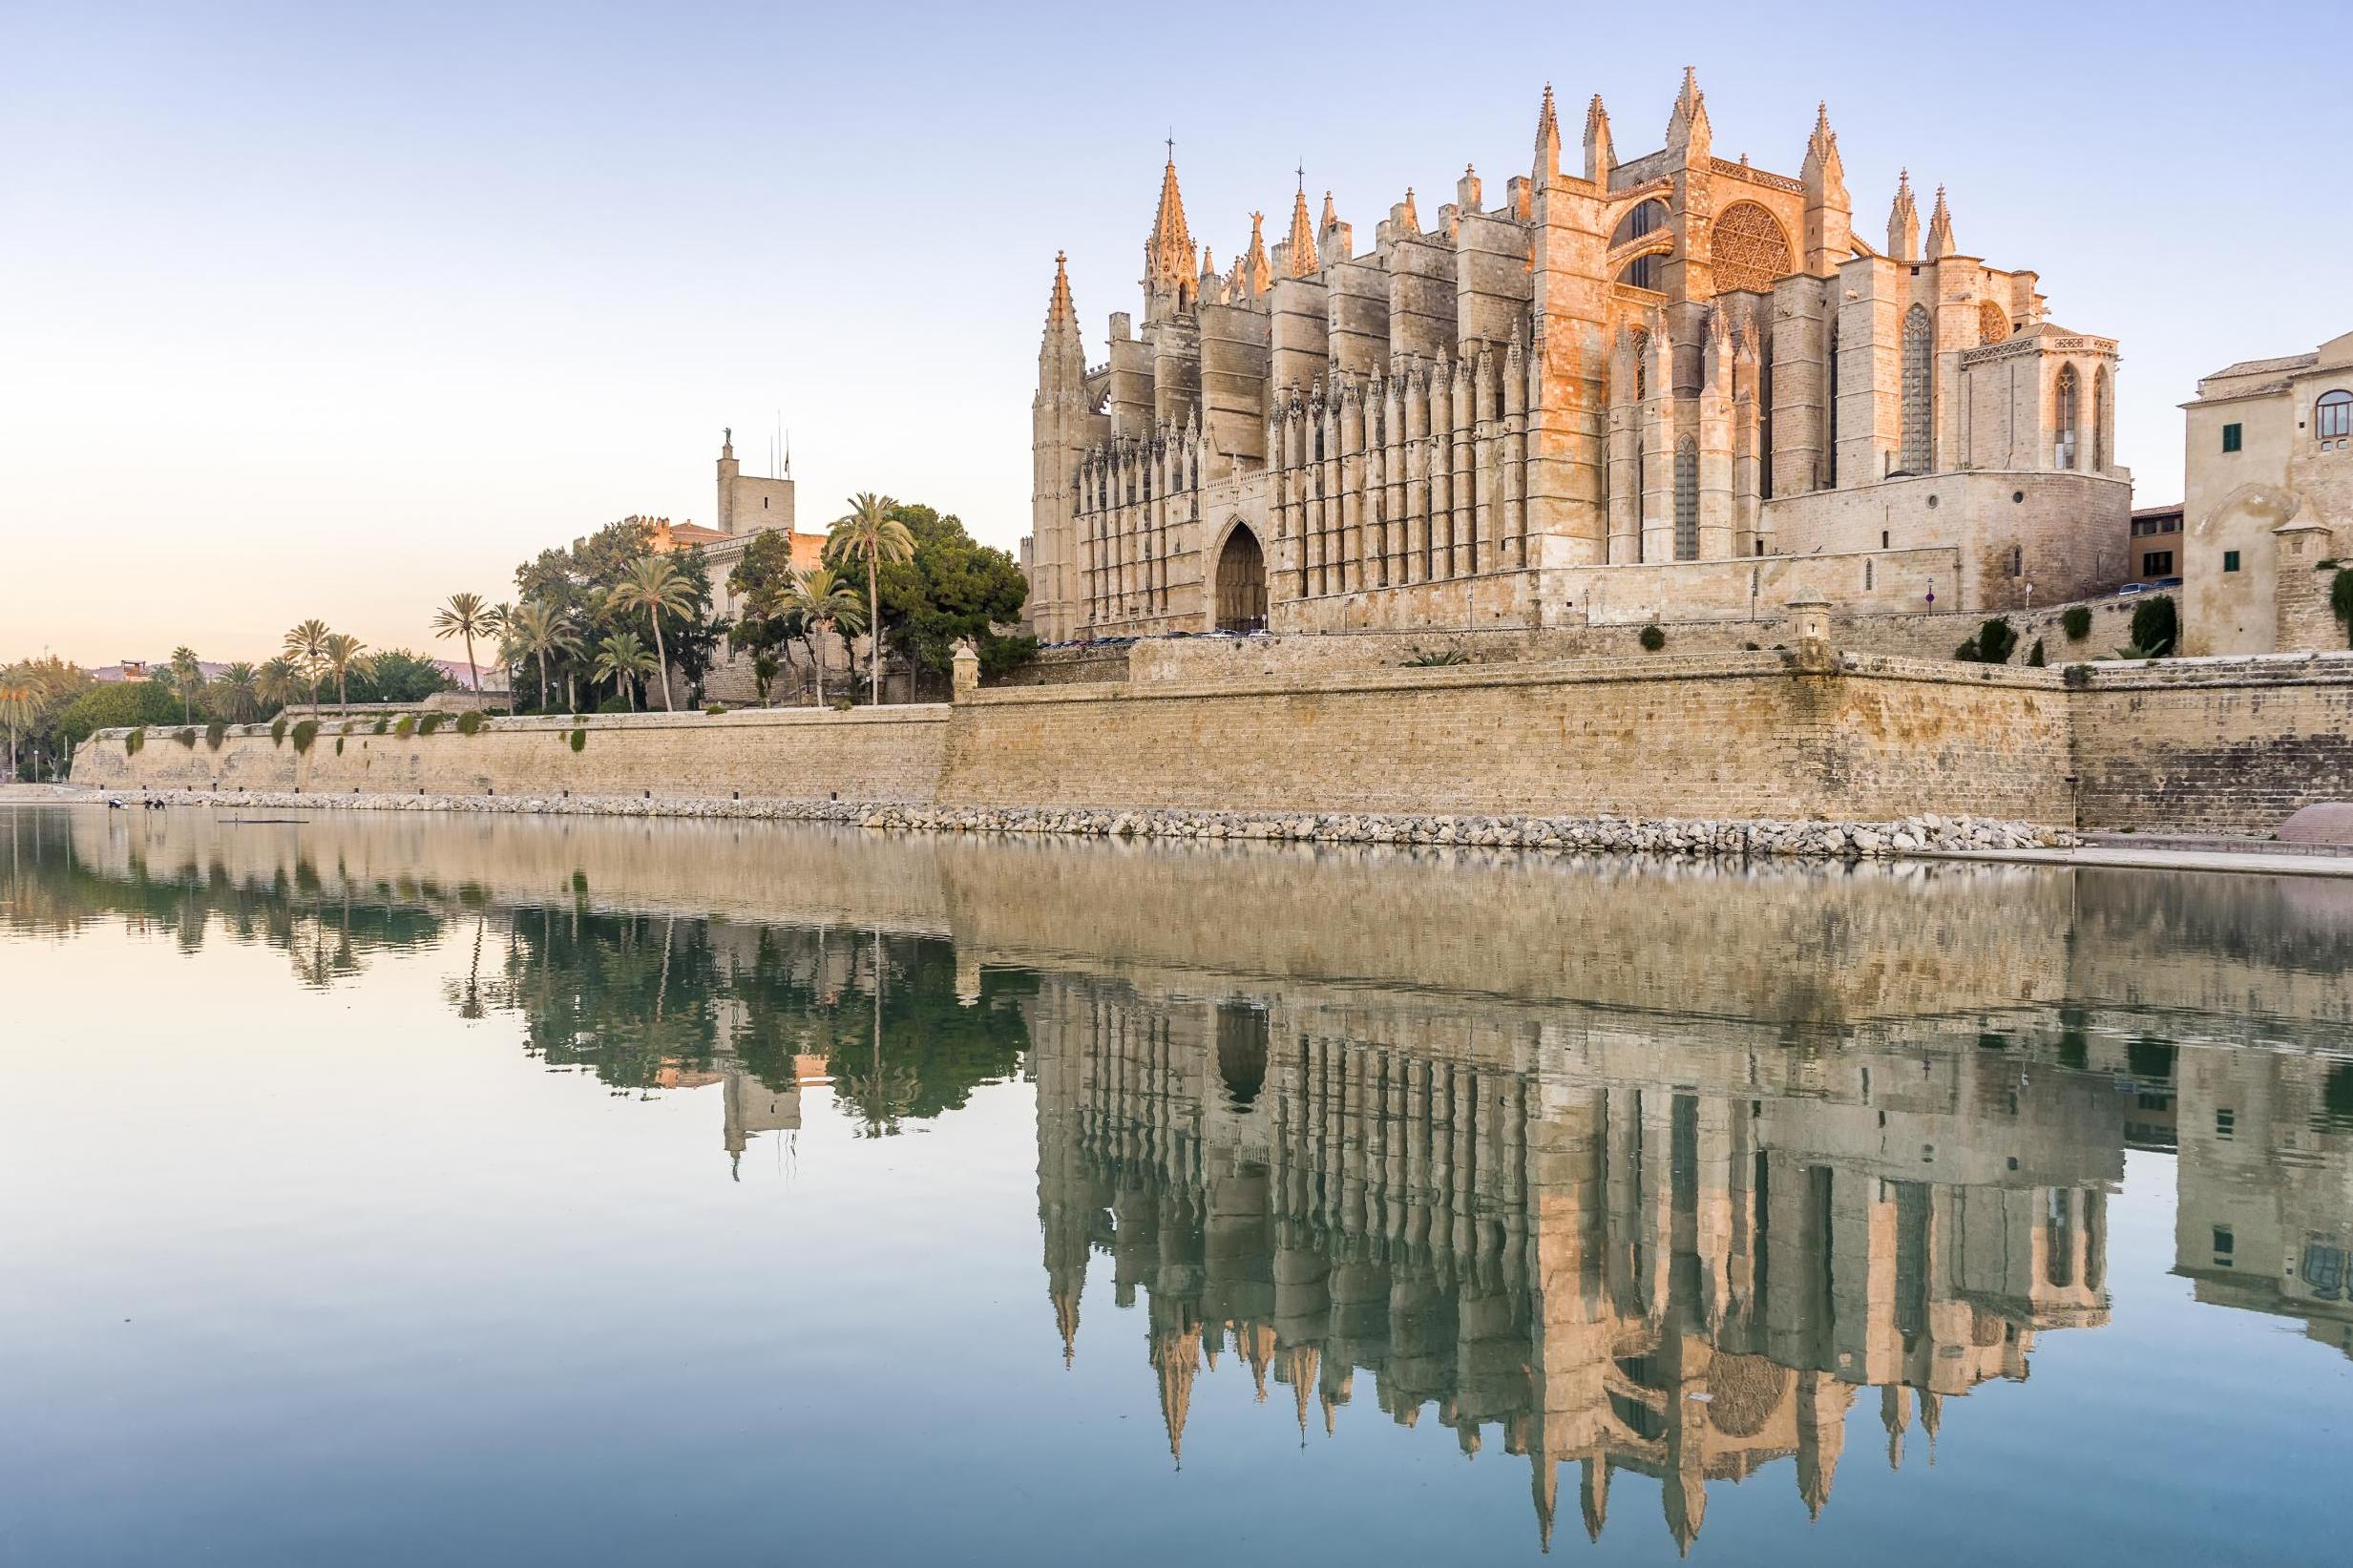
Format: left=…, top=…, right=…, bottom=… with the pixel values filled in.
left=82, top=790, right=2078, bottom=858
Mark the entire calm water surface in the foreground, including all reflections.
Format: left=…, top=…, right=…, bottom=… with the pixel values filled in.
left=0, top=806, right=2353, bottom=1568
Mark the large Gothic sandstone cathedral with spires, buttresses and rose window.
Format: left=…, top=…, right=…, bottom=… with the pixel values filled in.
left=1023, top=73, right=2132, bottom=641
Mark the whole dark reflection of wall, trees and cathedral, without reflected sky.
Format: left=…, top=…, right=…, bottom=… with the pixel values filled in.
left=5, top=811, right=2353, bottom=1549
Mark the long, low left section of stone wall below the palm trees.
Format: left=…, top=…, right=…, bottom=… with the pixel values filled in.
left=73, top=703, right=948, bottom=802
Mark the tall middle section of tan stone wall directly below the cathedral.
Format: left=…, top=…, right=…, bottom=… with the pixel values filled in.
left=941, top=654, right=2069, bottom=823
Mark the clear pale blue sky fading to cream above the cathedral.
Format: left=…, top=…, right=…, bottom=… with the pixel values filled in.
left=0, top=0, right=2353, bottom=663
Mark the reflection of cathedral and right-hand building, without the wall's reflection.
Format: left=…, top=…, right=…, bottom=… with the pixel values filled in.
left=1031, top=980, right=2353, bottom=1547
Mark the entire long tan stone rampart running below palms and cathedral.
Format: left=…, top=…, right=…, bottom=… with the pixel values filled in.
left=75, top=639, right=2353, bottom=832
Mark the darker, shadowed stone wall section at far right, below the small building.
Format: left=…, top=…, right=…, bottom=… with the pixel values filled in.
left=2075, top=654, right=2353, bottom=832
